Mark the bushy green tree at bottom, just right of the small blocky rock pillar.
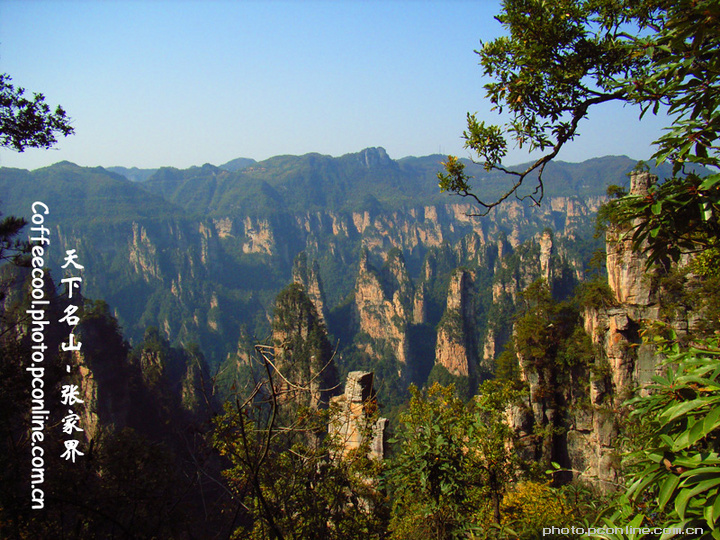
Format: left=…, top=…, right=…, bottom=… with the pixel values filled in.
left=385, top=381, right=518, bottom=539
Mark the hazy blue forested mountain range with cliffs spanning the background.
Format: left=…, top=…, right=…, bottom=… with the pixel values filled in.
left=0, top=148, right=676, bottom=384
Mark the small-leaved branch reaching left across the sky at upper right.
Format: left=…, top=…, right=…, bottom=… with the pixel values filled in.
left=438, top=0, right=648, bottom=213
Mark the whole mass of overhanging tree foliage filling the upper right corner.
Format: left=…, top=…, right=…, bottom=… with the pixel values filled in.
left=438, top=0, right=720, bottom=262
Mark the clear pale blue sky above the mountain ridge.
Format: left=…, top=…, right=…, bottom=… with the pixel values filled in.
left=0, top=0, right=664, bottom=169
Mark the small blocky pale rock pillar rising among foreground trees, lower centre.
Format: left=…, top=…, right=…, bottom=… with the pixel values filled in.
left=328, top=371, right=388, bottom=459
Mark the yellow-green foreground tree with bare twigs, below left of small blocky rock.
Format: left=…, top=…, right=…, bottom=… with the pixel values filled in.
left=212, top=347, right=384, bottom=540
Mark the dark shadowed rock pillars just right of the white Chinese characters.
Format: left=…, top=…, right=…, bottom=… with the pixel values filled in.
left=65, top=307, right=214, bottom=441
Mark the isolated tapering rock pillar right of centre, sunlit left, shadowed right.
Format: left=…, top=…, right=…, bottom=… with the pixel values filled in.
left=435, top=270, right=477, bottom=377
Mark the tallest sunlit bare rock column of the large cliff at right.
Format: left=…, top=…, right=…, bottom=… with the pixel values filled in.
left=567, top=172, right=659, bottom=490
